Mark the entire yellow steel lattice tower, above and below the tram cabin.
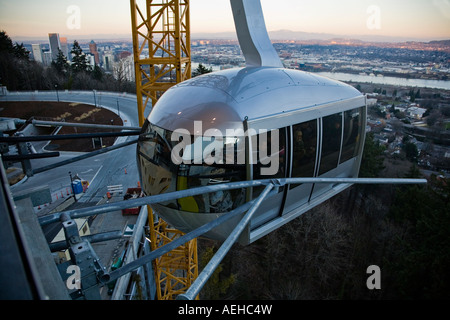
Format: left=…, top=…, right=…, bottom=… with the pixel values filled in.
left=130, top=0, right=198, bottom=300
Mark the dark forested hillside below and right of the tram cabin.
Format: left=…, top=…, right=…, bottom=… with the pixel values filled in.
left=200, top=135, right=450, bottom=300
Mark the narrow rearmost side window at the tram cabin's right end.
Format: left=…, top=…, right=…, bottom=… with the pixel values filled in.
left=340, top=108, right=362, bottom=163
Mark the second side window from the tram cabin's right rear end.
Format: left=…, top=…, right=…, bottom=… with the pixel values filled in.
left=319, top=113, right=342, bottom=176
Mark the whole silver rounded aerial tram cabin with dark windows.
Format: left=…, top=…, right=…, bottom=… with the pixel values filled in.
left=137, top=67, right=367, bottom=245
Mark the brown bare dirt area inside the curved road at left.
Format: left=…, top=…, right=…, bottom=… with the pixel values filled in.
left=0, top=101, right=123, bottom=152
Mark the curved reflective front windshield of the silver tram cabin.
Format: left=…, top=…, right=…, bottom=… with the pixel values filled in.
left=137, top=122, right=246, bottom=213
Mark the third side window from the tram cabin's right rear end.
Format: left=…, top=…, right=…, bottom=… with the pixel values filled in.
left=291, top=120, right=317, bottom=189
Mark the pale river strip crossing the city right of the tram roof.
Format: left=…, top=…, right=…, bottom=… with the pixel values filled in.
left=317, top=72, right=450, bottom=90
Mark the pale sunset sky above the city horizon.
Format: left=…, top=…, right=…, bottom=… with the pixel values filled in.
left=0, top=0, right=450, bottom=40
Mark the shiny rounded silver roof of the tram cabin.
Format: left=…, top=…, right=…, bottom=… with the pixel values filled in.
left=149, top=67, right=364, bottom=132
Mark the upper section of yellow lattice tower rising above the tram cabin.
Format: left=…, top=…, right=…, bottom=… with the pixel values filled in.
left=130, top=0, right=191, bottom=126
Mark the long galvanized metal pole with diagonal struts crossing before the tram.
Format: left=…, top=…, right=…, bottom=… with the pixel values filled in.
left=39, top=178, right=427, bottom=300
